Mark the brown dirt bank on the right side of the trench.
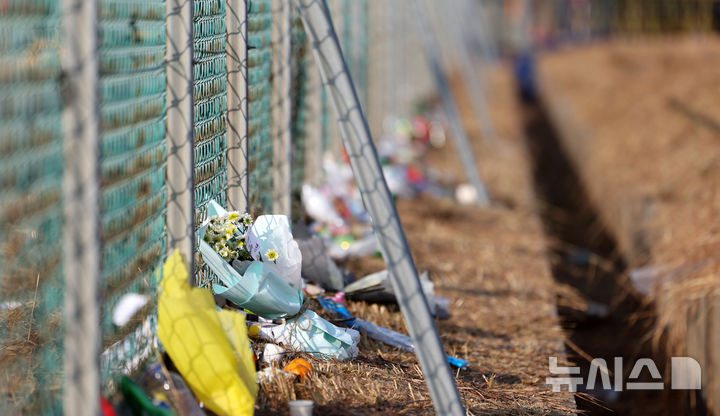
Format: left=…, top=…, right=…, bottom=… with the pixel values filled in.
left=539, top=37, right=720, bottom=408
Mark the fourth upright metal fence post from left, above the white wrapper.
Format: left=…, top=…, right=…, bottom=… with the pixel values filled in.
left=272, top=0, right=292, bottom=216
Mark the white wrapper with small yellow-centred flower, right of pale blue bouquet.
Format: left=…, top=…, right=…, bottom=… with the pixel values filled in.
left=246, top=215, right=302, bottom=289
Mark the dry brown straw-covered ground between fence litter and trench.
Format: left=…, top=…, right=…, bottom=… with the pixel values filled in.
left=257, top=68, right=574, bottom=415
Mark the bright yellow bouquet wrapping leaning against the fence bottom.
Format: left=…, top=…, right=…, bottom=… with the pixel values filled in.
left=158, top=250, right=257, bottom=416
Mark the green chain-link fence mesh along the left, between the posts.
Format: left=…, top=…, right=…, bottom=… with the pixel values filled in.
left=0, top=0, right=466, bottom=414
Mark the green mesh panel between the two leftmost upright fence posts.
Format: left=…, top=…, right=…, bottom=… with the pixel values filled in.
left=98, top=0, right=167, bottom=389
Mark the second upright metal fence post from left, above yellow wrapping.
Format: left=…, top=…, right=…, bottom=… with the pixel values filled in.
left=166, top=0, right=195, bottom=272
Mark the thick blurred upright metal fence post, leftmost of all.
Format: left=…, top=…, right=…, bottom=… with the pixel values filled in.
left=62, top=0, right=101, bottom=415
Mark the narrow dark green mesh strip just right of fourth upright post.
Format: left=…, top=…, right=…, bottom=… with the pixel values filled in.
left=290, top=8, right=310, bottom=219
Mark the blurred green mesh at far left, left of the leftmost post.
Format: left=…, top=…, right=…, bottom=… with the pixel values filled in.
left=0, top=0, right=64, bottom=415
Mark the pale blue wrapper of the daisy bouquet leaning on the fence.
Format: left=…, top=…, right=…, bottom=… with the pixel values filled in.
left=198, top=201, right=303, bottom=319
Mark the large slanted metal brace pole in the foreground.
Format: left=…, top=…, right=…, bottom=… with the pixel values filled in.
left=296, top=0, right=465, bottom=415
